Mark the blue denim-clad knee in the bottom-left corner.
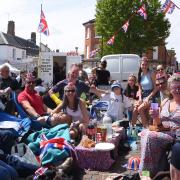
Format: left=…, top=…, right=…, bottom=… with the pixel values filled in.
left=0, top=160, right=18, bottom=180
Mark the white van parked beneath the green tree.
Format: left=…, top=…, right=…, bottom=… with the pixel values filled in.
left=101, top=54, right=140, bottom=82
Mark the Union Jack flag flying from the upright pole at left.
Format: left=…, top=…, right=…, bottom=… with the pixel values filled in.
left=38, top=9, right=49, bottom=36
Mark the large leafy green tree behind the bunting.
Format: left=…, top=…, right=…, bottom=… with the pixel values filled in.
left=95, top=0, right=170, bottom=55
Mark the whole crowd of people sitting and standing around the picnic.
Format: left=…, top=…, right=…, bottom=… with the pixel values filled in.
left=0, top=57, right=180, bottom=180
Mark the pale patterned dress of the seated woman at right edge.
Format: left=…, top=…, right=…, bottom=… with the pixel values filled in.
left=140, top=100, right=180, bottom=176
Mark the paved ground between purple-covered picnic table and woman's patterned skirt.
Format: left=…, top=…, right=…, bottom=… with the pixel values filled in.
left=82, top=139, right=140, bottom=180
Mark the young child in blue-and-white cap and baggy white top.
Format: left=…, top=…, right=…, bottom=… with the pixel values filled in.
left=95, top=81, right=132, bottom=124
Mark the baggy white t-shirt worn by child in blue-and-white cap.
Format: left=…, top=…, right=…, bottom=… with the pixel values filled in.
left=101, top=92, right=132, bottom=119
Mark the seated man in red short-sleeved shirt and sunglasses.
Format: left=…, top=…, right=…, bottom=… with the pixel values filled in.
left=18, top=74, right=71, bottom=126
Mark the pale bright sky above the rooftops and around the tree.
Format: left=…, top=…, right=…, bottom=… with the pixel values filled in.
left=0, top=0, right=180, bottom=62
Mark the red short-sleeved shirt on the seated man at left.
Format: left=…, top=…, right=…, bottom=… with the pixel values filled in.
left=18, top=88, right=46, bottom=115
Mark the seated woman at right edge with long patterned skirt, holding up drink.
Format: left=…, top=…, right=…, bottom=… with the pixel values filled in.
left=140, top=74, right=180, bottom=177
